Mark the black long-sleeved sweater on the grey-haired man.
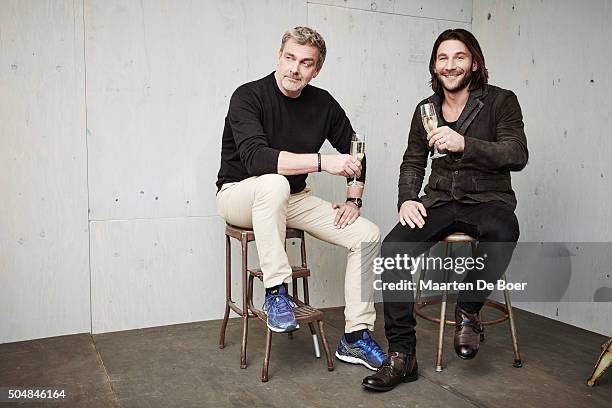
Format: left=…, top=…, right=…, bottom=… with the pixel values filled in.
left=217, top=73, right=365, bottom=194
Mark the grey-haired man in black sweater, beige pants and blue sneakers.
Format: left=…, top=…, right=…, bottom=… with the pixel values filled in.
left=217, top=27, right=385, bottom=370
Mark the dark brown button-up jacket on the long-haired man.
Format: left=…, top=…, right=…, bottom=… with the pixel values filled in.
left=398, top=85, right=529, bottom=209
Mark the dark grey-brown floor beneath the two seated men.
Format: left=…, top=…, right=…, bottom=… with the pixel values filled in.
left=0, top=305, right=612, bottom=408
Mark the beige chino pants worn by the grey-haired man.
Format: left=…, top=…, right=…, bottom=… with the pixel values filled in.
left=217, top=174, right=380, bottom=333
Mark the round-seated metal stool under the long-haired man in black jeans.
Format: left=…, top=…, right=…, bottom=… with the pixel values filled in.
left=414, top=233, right=523, bottom=372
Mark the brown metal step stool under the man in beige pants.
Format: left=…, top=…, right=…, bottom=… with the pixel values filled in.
left=219, top=224, right=334, bottom=382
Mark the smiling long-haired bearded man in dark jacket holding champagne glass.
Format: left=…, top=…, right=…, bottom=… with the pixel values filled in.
left=363, top=29, right=528, bottom=391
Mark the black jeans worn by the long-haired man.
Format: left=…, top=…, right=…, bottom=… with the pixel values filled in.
left=382, top=201, right=519, bottom=353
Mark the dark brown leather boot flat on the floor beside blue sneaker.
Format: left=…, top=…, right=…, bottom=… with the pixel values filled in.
left=361, top=351, right=419, bottom=391
